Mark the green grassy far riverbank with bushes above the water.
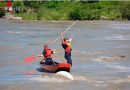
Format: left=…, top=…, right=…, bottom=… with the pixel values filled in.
left=0, top=1, right=130, bottom=20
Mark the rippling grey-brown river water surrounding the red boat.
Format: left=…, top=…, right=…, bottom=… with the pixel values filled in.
left=0, top=20, right=130, bottom=90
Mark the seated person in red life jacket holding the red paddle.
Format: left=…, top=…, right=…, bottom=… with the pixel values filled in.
left=38, top=44, right=55, bottom=65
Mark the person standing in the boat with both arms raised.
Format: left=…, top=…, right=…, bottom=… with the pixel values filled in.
left=61, top=35, right=73, bottom=65
